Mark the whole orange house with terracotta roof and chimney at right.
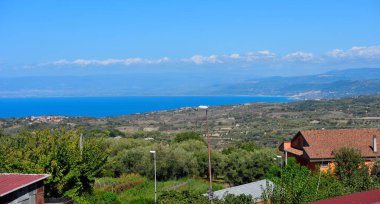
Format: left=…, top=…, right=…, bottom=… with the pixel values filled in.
left=279, top=128, right=380, bottom=171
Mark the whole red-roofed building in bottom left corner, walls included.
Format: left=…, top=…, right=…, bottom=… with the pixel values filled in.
left=0, top=173, right=50, bottom=204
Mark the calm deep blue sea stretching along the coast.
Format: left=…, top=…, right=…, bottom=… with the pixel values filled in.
left=0, top=96, right=292, bottom=118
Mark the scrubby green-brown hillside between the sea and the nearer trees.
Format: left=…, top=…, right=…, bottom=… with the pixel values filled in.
left=0, top=95, right=380, bottom=147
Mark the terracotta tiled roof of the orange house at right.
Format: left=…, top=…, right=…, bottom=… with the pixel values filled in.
left=300, top=128, right=380, bottom=159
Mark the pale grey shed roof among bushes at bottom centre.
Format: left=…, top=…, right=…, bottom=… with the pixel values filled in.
left=206, top=179, right=274, bottom=201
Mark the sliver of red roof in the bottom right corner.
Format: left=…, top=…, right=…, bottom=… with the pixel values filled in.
left=311, top=189, right=380, bottom=204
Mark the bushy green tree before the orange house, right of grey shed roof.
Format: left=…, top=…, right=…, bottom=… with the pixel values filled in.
left=268, top=158, right=347, bottom=204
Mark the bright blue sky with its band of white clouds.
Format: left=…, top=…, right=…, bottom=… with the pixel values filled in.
left=0, top=0, right=380, bottom=76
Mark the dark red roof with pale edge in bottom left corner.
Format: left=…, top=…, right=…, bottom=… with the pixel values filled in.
left=0, top=174, right=50, bottom=197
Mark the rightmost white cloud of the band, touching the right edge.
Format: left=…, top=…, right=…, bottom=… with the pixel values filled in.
left=326, top=45, right=380, bottom=59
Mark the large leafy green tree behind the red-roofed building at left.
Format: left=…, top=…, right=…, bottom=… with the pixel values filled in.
left=0, top=129, right=107, bottom=197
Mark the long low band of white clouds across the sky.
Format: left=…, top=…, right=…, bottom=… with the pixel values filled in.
left=43, top=45, right=380, bottom=66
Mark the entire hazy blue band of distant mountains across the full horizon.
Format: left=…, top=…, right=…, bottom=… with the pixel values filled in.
left=0, top=68, right=380, bottom=99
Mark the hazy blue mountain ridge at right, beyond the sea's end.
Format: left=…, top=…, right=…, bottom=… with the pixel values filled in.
left=212, top=68, right=380, bottom=99
